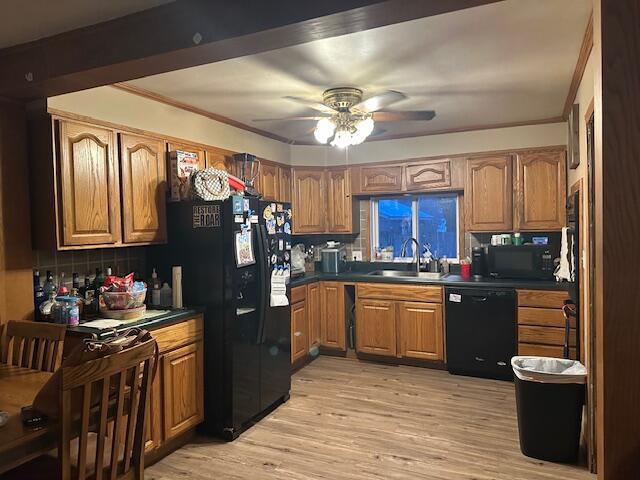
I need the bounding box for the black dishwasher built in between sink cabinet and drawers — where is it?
[445,287,516,380]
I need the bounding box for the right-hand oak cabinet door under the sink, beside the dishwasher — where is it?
[398,302,444,360]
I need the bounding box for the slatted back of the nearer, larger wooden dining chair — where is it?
[59,340,156,480]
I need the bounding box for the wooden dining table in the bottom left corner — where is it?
[0,363,56,474]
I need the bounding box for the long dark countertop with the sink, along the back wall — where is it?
[291,268,574,291]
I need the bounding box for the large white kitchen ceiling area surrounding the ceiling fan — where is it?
[129,0,591,141]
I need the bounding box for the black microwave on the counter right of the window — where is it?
[487,245,555,280]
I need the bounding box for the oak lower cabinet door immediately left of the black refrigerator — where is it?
[162,341,204,441]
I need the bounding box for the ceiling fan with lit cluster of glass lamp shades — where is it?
[254,87,436,148]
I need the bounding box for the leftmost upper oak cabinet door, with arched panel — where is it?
[57,120,121,246]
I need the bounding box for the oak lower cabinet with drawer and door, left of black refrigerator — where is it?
[145,315,204,458]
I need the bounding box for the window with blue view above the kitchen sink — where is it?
[371,193,458,258]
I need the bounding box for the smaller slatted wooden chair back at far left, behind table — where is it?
[0,320,67,372]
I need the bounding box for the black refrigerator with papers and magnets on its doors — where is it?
[166,196,292,440]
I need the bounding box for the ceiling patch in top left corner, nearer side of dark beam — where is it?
[0,0,173,48]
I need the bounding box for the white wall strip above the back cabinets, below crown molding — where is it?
[291,122,567,165]
